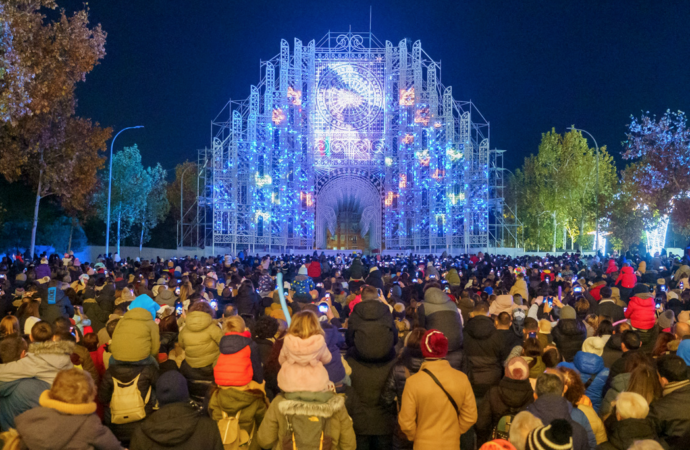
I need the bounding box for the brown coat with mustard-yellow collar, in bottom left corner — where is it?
[15,391,122,450]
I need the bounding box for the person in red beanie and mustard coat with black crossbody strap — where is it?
[398,329,477,450]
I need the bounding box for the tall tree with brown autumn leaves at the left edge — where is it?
[0,0,111,255]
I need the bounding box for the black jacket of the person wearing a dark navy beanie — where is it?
[129,403,223,450]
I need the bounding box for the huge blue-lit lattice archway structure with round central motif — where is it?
[206,33,494,251]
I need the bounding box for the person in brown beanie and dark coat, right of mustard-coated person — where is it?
[476,356,534,444]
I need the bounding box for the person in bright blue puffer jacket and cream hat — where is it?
[558,337,609,413]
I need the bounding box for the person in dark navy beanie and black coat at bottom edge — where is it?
[129,370,224,450]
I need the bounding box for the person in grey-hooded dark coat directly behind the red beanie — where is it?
[417,287,463,370]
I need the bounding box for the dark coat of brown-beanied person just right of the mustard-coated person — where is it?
[476,377,534,445]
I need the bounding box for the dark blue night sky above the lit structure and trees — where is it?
[58,0,690,173]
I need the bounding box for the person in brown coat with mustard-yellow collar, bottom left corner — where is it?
[14,368,122,450]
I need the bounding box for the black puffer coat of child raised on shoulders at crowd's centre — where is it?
[346,300,398,362]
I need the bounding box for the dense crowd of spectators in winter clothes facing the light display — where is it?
[0,252,690,450]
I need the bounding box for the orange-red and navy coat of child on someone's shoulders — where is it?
[213,331,264,386]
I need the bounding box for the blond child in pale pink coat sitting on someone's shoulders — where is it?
[278,311,333,392]
